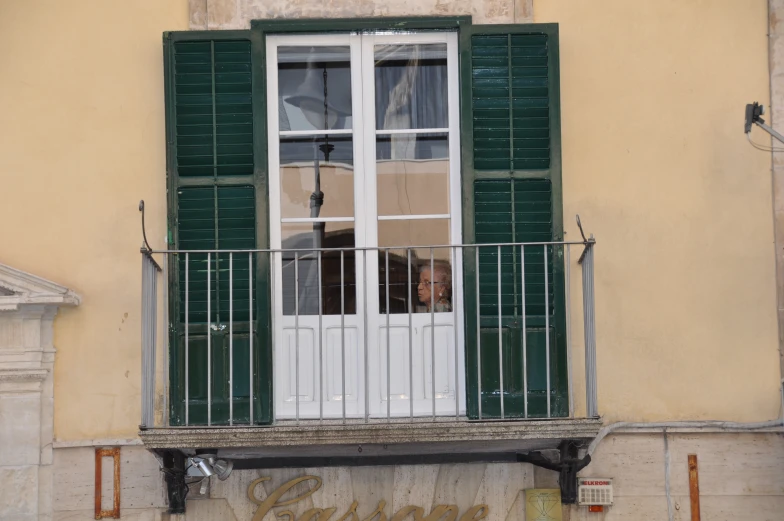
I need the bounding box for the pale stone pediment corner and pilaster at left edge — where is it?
[0,264,81,521]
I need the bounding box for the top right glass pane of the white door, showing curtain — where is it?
[375,43,449,130]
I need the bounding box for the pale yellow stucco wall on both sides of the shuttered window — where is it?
[0,0,779,439]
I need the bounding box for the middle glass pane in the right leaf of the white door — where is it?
[376,134,449,216]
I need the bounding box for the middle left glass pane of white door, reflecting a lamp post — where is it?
[280,136,354,218]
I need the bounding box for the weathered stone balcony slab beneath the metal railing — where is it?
[139,418,602,458]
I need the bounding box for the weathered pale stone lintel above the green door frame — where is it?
[188,0,533,30]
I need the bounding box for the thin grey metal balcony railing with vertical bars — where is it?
[141,239,598,429]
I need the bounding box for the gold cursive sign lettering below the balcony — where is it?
[248,476,490,521]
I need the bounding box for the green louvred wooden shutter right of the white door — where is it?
[461,24,568,418]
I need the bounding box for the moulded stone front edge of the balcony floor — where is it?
[139,418,602,451]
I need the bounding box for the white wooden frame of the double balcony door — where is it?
[266,31,467,419]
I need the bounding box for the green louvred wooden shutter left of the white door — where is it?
[164,31,271,425]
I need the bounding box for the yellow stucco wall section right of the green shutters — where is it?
[534,0,780,421]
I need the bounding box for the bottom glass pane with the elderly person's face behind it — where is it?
[378,219,453,313]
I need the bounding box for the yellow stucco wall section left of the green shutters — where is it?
[0,0,188,439]
